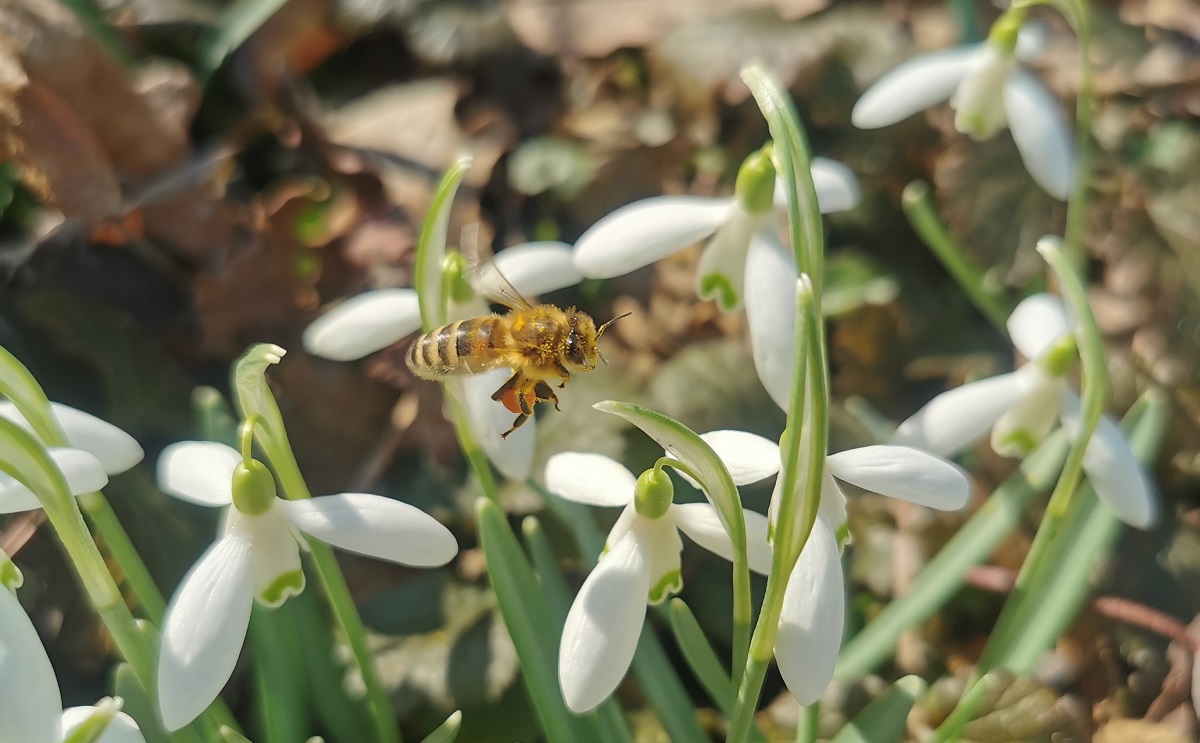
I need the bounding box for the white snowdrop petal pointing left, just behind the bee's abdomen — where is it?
[301,289,421,361]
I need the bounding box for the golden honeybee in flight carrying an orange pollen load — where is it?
[404,250,628,438]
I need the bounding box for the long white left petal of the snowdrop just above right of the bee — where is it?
[575,196,737,278]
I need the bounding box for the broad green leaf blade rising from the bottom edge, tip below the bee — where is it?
[475,498,594,743]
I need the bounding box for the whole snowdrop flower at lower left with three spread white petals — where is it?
[158,442,458,730]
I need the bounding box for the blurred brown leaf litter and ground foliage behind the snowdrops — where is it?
[0,0,1200,742]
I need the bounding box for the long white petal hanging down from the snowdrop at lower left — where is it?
[158,534,253,730]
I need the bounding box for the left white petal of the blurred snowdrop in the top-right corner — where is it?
[850,44,985,128]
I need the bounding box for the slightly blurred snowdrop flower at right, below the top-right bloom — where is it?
[893,294,1158,529]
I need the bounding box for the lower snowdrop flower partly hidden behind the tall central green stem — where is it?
[701,431,971,705]
